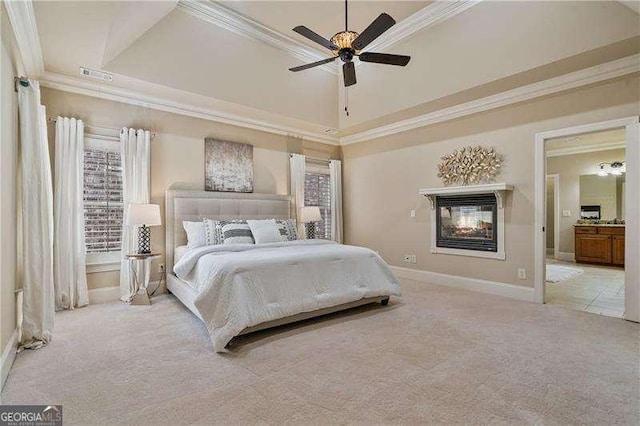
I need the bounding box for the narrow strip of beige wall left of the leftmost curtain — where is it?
[0,6,18,351]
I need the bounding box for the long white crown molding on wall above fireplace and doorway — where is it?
[340,55,640,145]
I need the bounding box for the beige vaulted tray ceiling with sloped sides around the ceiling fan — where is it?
[28,0,640,143]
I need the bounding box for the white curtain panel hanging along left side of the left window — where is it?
[53,117,89,310]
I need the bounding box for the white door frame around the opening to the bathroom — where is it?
[533,116,640,322]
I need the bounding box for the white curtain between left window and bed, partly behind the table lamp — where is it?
[120,128,151,302]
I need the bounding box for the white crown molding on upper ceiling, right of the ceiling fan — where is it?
[366,0,481,55]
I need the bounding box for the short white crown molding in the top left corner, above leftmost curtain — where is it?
[3,0,44,78]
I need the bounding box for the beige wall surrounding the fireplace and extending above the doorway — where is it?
[343,75,640,287]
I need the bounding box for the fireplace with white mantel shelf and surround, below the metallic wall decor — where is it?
[420,183,513,260]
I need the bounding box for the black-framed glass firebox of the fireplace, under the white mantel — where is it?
[436,194,498,252]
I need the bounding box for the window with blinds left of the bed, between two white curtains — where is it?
[84,138,123,263]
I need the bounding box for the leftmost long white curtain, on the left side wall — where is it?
[17,81,55,348]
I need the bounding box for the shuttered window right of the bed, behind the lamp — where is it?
[304,163,331,240]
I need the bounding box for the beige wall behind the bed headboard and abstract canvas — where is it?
[42,88,341,288]
